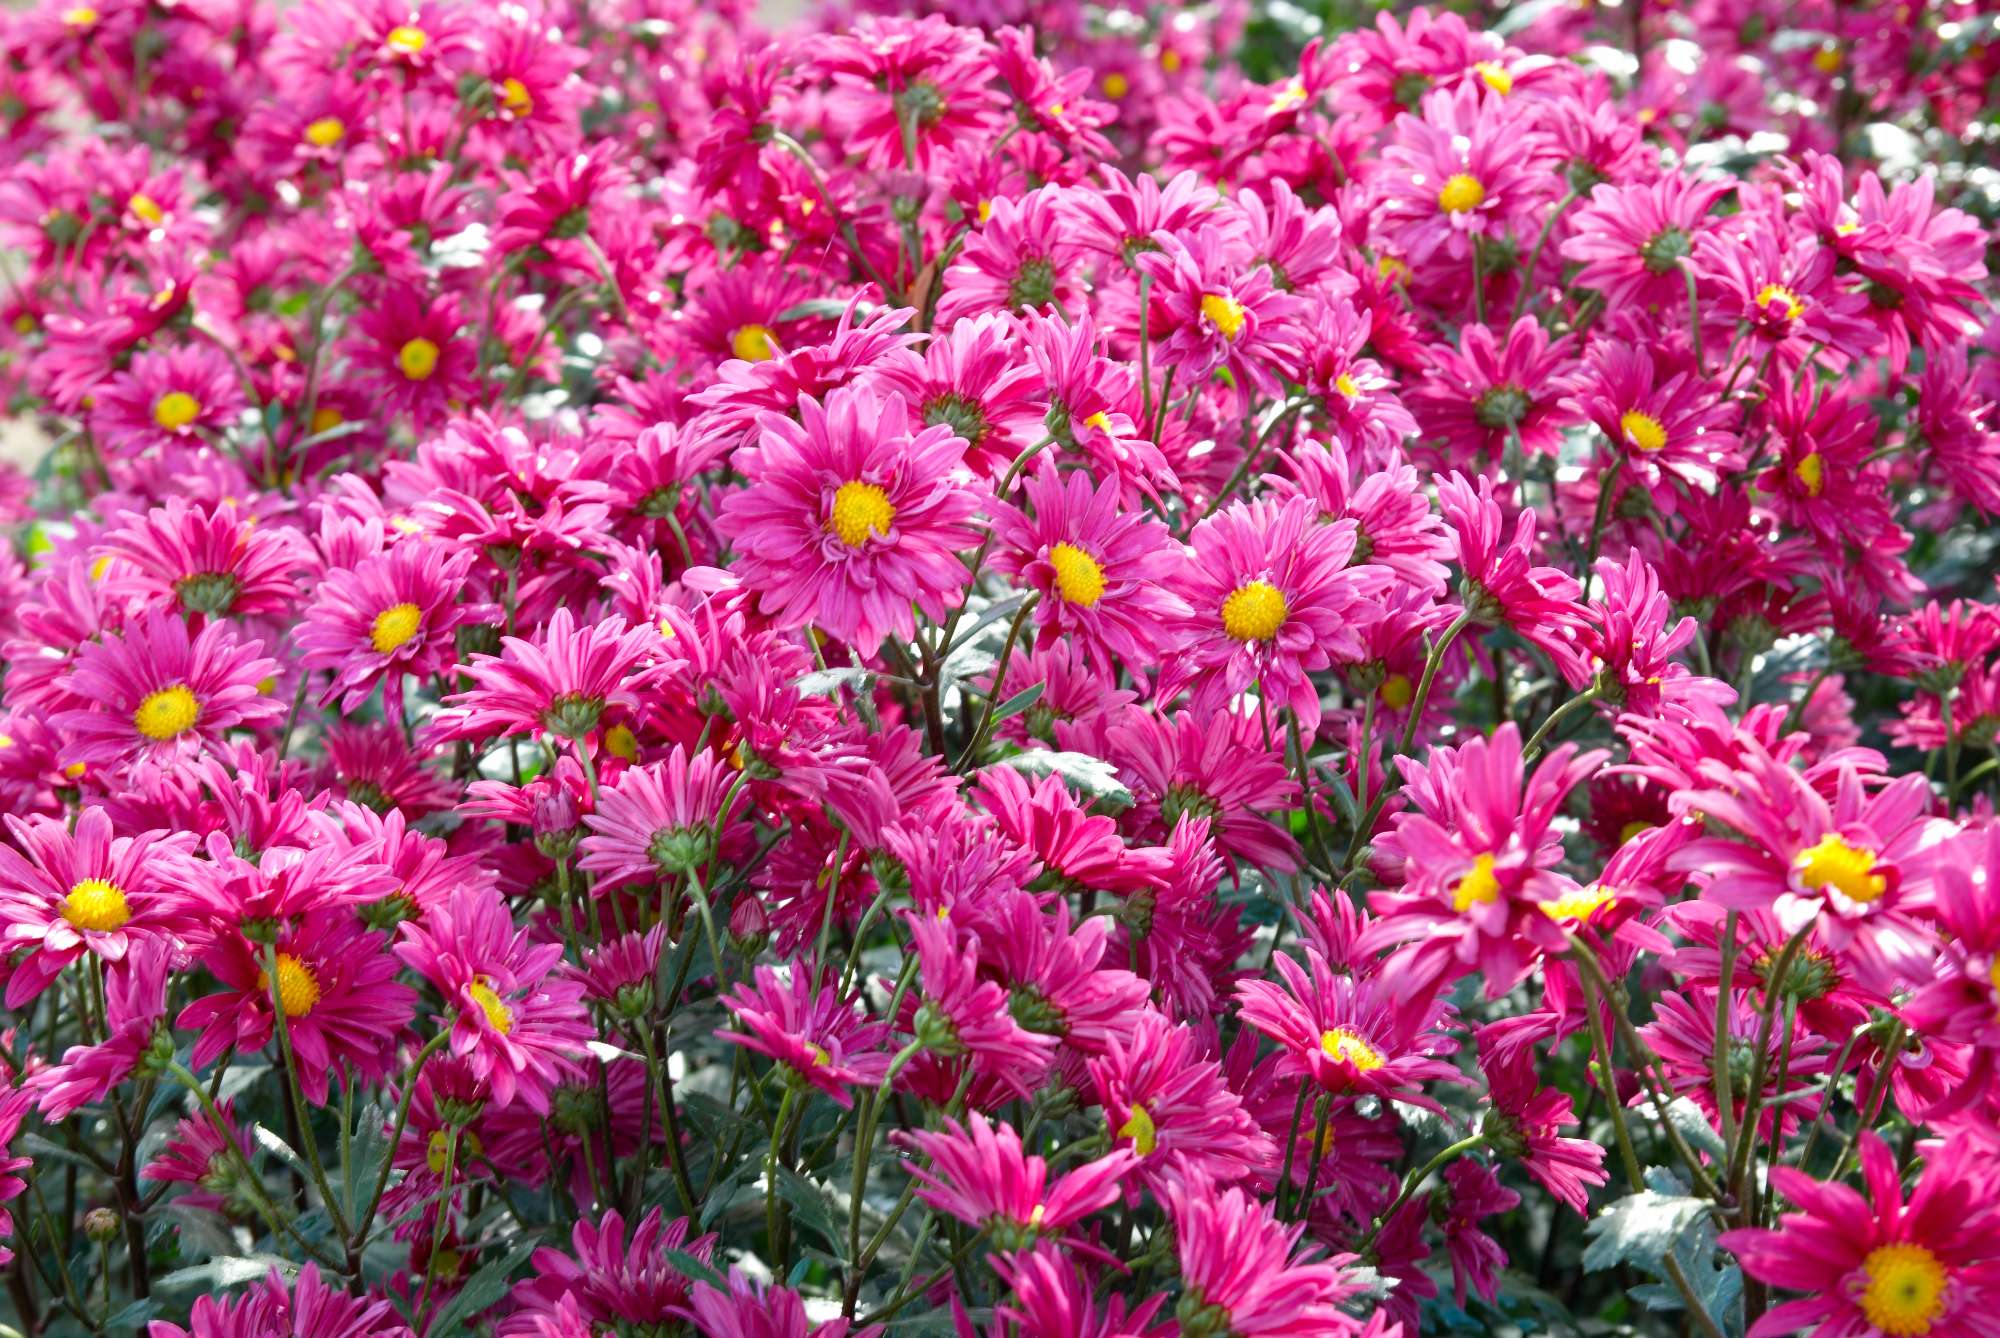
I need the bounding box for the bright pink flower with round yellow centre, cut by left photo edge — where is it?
[0,806,194,1008]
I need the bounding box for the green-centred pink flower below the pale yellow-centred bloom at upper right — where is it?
[1408,316,1576,460]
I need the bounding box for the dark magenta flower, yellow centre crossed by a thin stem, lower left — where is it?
[174,910,416,1106]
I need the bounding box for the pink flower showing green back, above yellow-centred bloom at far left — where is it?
[100,498,302,618]
